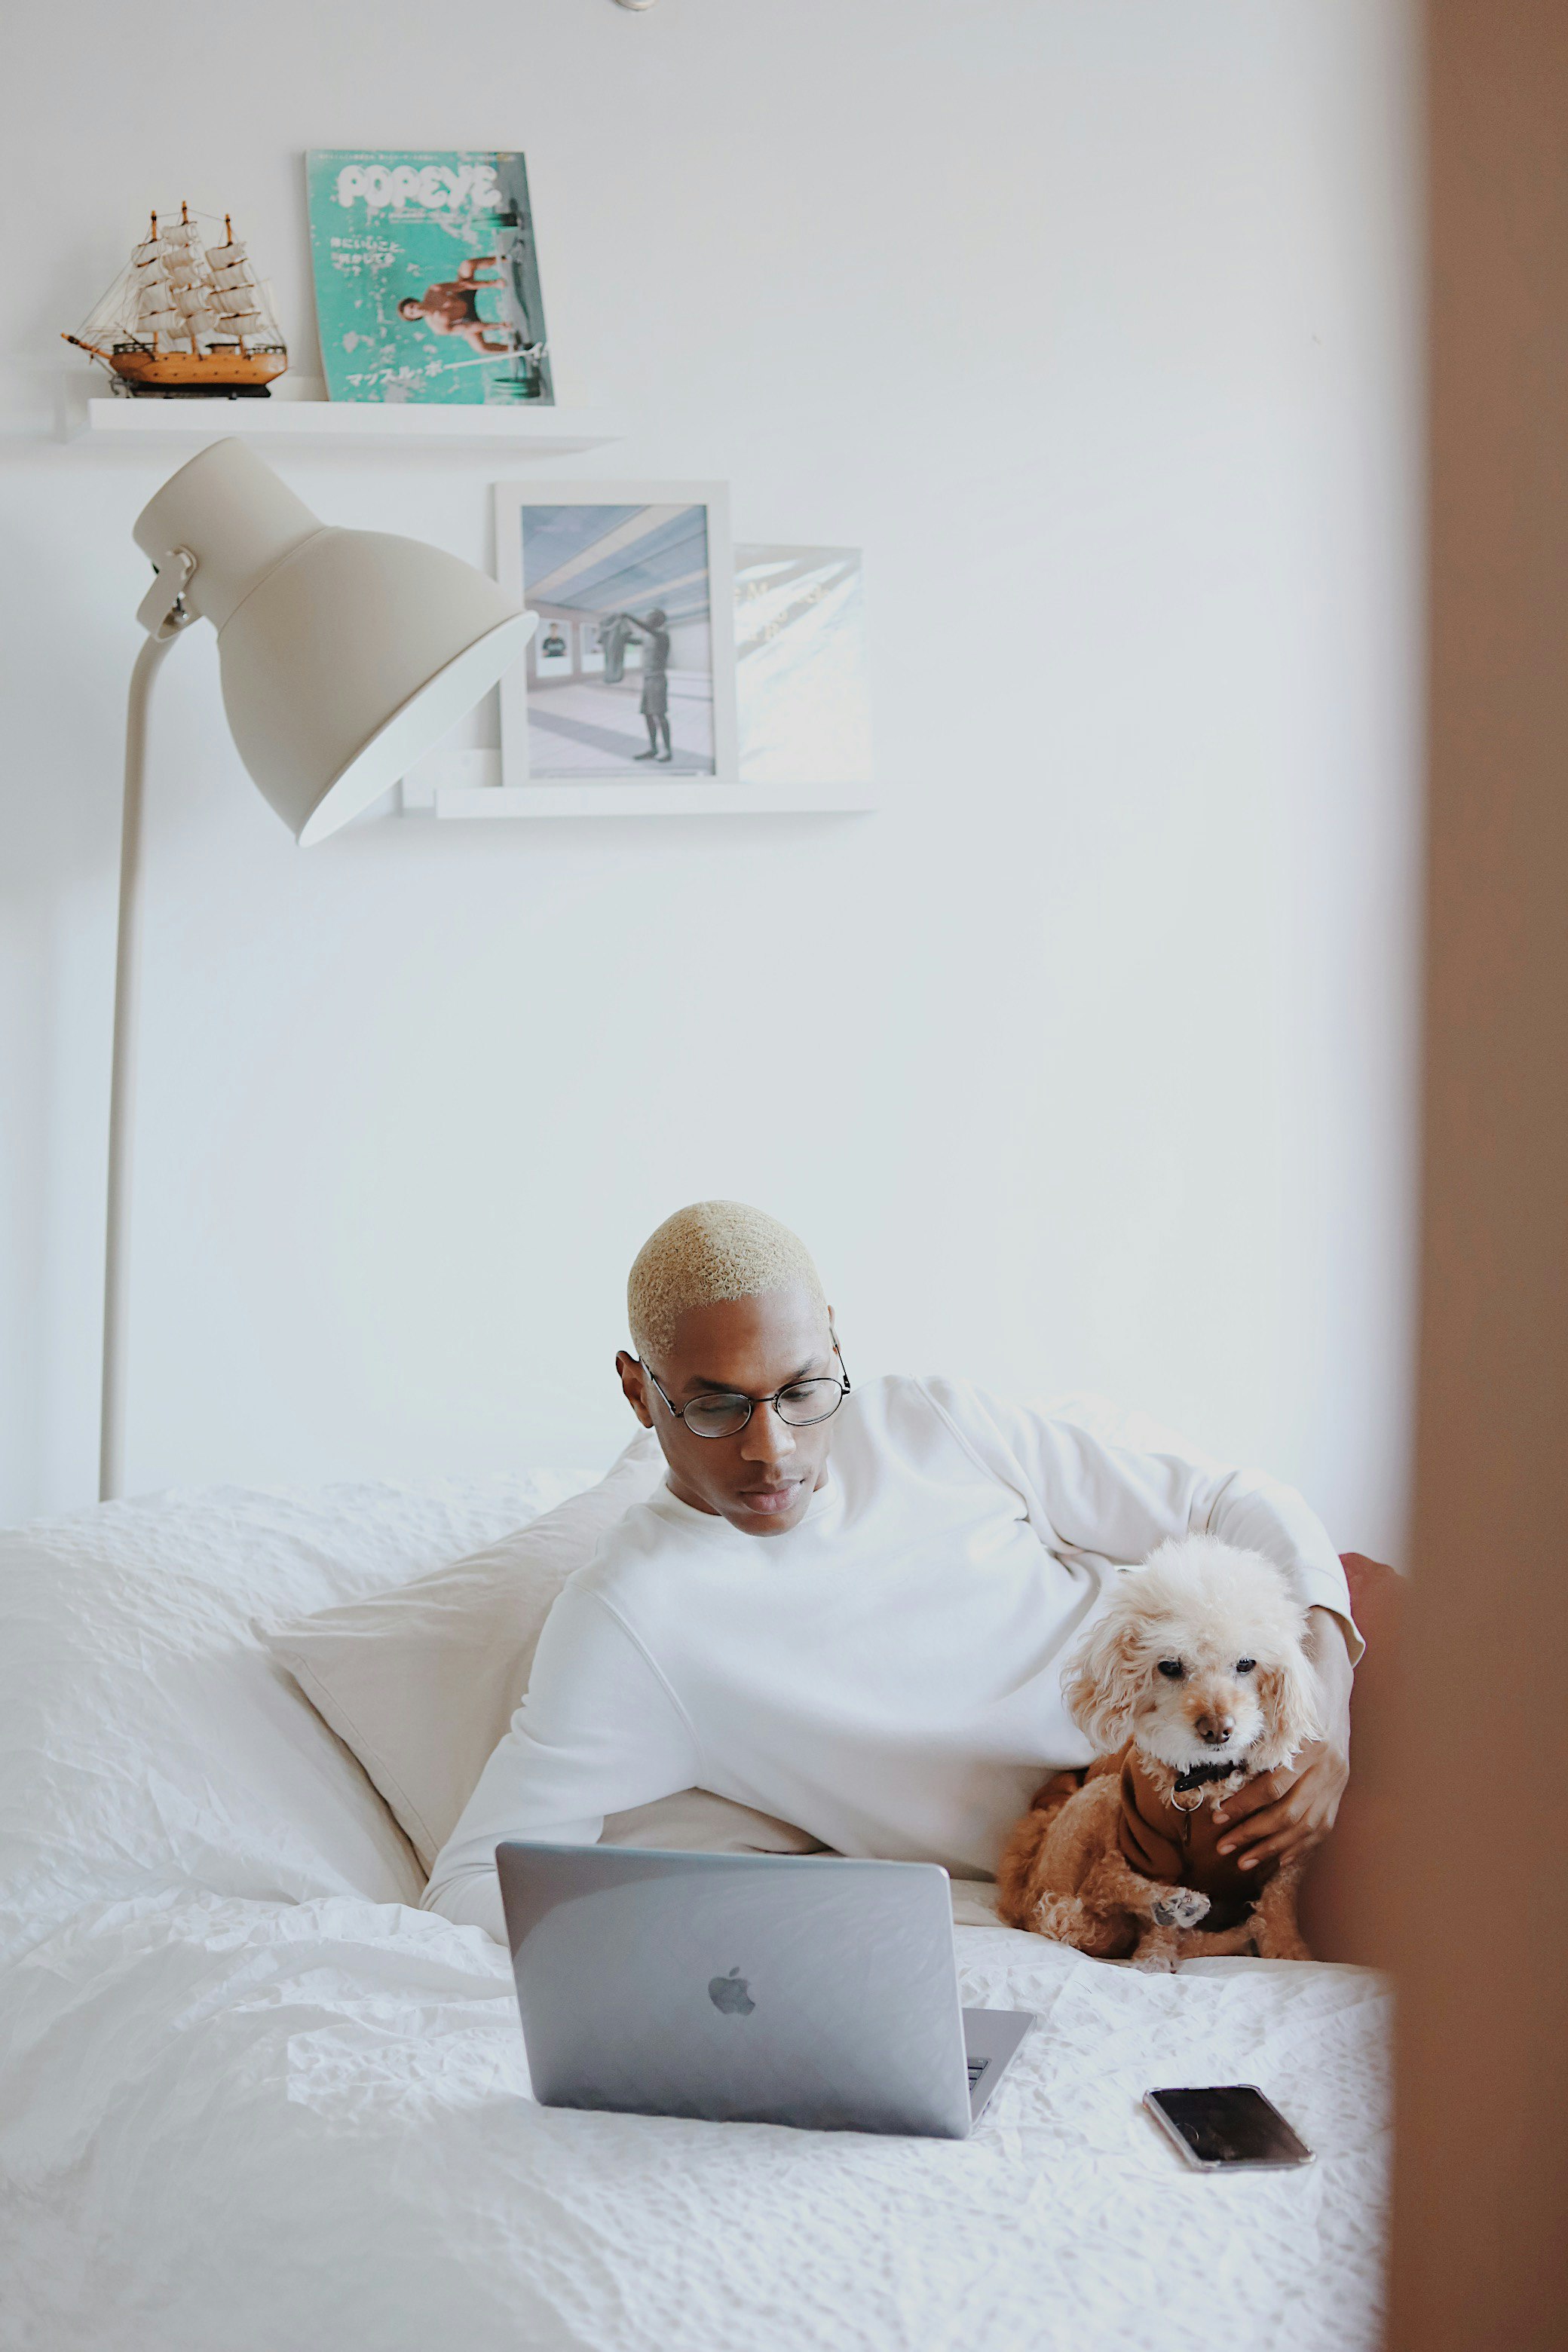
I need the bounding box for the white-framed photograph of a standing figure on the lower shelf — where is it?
[496,482,738,804]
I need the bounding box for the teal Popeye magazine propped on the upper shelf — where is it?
[305,149,555,407]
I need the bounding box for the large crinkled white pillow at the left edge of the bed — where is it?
[0,1472,587,1956]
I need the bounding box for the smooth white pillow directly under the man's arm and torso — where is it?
[261,1430,820,1875]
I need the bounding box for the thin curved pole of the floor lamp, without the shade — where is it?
[99,628,179,1503]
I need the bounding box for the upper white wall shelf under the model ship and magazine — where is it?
[63,400,623,458]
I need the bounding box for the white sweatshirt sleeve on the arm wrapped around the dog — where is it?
[924,1380,1366,1665]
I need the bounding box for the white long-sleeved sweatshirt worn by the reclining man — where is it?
[425,1378,1361,1940]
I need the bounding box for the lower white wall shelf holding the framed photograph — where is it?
[402,750,881,823]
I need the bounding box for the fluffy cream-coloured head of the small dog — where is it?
[1065,1536,1316,1771]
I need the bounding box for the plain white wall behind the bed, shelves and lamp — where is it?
[0,0,1415,1550]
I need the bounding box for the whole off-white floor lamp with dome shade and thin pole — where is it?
[99,439,536,1501]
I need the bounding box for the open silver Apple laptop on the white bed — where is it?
[496,1839,1034,2140]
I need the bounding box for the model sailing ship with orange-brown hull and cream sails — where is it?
[66,204,289,400]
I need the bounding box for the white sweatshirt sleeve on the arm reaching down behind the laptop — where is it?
[423,1581,700,1943]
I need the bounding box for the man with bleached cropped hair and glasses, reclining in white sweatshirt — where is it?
[425,1199,1361,1938]
